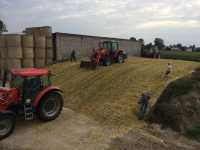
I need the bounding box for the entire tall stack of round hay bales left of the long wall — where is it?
[0,27,53,75]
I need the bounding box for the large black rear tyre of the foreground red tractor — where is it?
[38,91,64,121]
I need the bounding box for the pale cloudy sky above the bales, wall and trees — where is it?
[0,0,200,46]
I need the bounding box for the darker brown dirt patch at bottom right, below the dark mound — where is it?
[107,125,200,150]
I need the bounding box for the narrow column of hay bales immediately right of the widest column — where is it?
[22,34,34,68]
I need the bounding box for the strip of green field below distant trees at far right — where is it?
[161,51,200,61]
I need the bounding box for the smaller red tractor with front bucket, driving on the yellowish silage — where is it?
[80,41,127,69]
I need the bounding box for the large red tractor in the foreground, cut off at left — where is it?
[0,68,63,140]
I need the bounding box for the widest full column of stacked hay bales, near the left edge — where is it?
[5,34,22,69]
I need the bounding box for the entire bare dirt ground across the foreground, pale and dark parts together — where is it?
[0,108,200,150]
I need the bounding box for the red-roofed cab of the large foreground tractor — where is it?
[10,68,51,103]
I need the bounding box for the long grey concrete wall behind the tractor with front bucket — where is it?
[53,33,141,61]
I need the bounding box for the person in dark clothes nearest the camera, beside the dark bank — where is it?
[138,92,151,117]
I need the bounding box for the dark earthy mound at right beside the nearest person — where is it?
[149,69,200,132]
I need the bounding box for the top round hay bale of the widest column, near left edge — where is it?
[5,34,21,47]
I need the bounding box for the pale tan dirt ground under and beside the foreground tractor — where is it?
[0,108,109,150]
